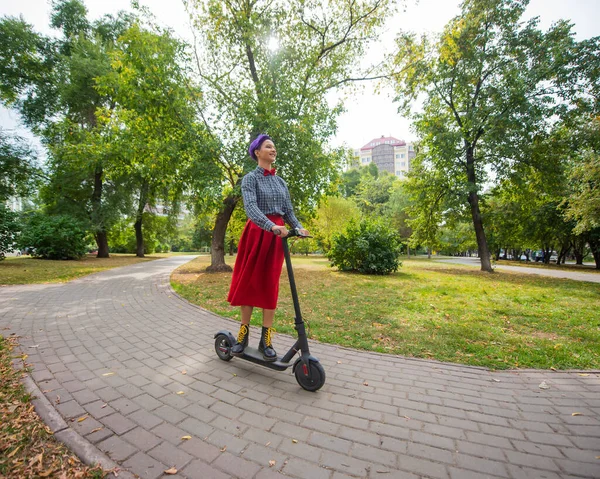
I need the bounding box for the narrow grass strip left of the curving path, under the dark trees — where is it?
[0,254,168,285]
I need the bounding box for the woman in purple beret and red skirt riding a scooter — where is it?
[227,135,309,361]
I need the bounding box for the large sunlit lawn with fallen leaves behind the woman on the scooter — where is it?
[172,256,600,369]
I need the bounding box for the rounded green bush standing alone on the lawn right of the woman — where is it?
[327,221,401,274]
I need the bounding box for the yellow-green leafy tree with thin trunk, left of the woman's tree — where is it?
[96,24,218,257]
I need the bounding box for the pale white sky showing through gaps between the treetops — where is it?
[0,0,600,154]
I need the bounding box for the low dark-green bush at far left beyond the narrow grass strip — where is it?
[18,213,88,259]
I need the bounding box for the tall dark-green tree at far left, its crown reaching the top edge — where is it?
[0,0,132,257]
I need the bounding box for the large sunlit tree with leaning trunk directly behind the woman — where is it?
[185,0,394,271]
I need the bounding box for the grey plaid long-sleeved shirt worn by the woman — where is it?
[242,166,302,231]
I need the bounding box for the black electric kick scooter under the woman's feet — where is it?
[215,229,325,391]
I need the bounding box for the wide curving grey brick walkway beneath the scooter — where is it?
[0,256,600,479]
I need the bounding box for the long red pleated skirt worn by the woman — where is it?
[227,215,284,309]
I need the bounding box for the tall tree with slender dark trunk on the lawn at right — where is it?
[393,0,575,272]
